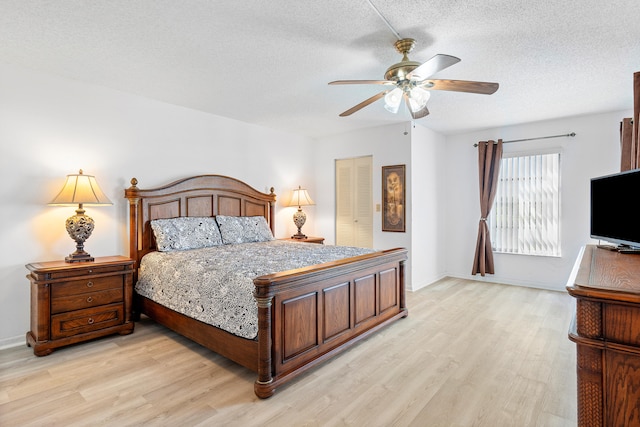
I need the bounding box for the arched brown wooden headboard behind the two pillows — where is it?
[124,175,276,272]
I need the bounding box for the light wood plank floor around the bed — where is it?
[0,279,576,427]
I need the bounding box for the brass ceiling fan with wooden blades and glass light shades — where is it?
[329,38,499,119]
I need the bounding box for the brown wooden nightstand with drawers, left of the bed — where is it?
[26,256,134,356]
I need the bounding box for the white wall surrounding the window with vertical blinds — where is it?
[445,110,632,290]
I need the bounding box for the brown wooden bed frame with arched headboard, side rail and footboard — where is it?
[125,175,408,398]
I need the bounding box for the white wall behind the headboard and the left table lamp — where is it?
[0,63,318,347]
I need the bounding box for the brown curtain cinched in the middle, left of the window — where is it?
[471,139,502,276]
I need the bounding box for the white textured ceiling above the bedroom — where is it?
[0,0,640,137]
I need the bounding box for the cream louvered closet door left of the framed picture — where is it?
[336,156,373,248]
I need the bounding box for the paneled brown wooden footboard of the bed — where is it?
[254,249,408,398]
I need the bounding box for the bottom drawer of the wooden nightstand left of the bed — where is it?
[51,304,124,339]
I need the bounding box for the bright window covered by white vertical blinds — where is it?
[489,153,560,256]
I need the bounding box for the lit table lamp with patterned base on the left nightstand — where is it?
[49,169,113,262]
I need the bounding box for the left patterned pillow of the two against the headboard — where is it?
[151,217,222,252]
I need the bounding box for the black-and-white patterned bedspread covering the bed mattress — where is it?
[135,240,374,339]
